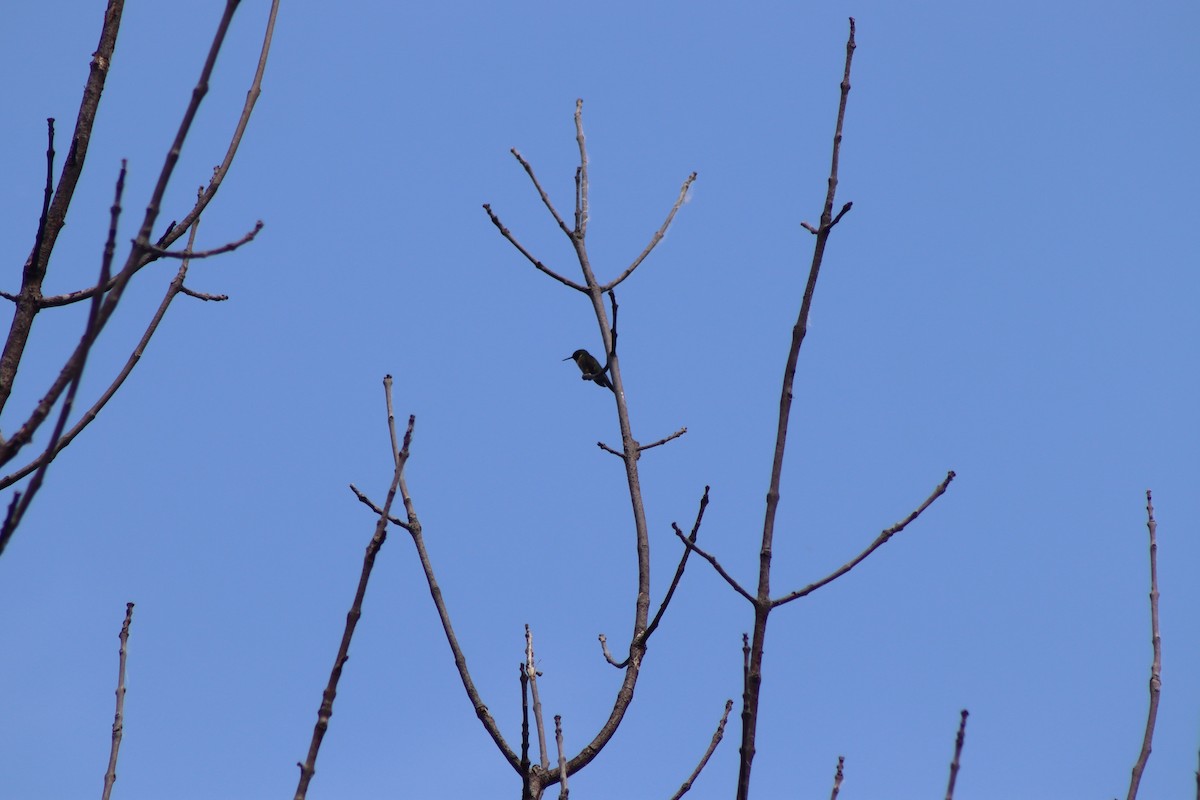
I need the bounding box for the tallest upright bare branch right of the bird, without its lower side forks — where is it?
[737,17,856,800]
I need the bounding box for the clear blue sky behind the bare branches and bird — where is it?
[0,0,1200,800]
